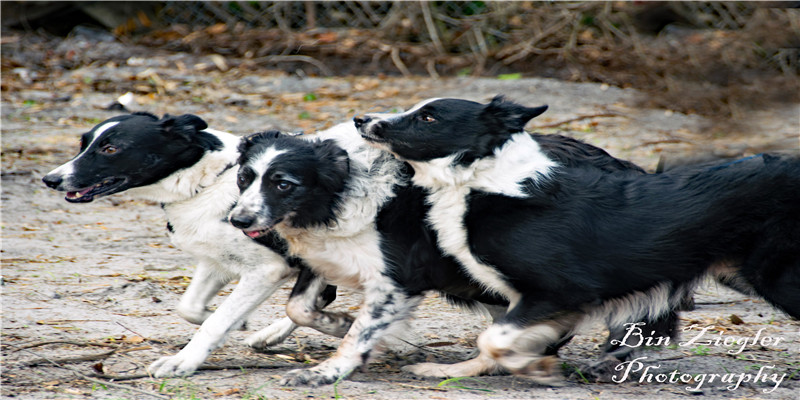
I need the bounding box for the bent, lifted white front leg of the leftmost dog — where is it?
[177,261,232,325]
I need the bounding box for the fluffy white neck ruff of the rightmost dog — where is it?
[408,132,558,197]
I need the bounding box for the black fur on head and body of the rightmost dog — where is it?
[357,95,800,373]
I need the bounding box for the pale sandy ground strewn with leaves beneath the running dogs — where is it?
[1,36,800,399]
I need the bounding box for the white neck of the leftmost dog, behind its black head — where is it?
[128,129,239,205]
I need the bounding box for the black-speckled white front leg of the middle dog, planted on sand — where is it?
[281,279,422,386]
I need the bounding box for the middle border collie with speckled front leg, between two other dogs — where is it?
[230,117,677,385]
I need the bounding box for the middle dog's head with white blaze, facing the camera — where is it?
[229,131,350,238]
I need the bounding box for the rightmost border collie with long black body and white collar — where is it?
[356,96,800,384]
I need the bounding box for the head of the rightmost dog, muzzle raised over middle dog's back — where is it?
[354,96,547,164]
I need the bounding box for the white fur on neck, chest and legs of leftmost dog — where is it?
[46,126,304,377]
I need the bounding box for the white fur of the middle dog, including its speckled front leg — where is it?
[234,124,428,386]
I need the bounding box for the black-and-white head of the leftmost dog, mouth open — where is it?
[42,113,222,203]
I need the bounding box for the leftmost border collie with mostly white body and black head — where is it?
[43,113,349,377]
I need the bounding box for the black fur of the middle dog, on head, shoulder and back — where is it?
[232,125,677,372]
